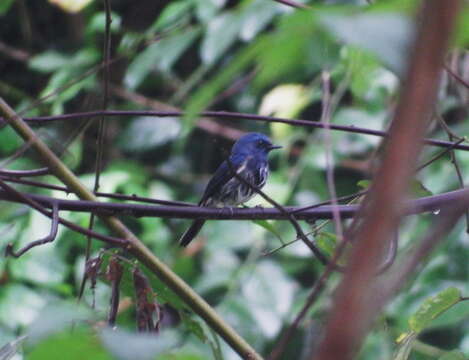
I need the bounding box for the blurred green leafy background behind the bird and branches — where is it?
[0,0,469,360]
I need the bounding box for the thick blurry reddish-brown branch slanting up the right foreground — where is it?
[314,0,460,360]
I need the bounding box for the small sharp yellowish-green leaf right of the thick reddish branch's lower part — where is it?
[409,287,461,333]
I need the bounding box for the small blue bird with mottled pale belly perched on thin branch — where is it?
[179,133,281,246]
